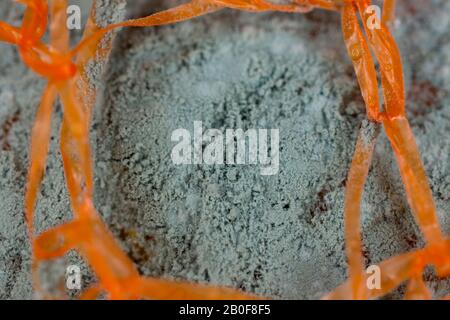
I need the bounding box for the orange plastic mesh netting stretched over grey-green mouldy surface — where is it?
[0,0,450,299]
